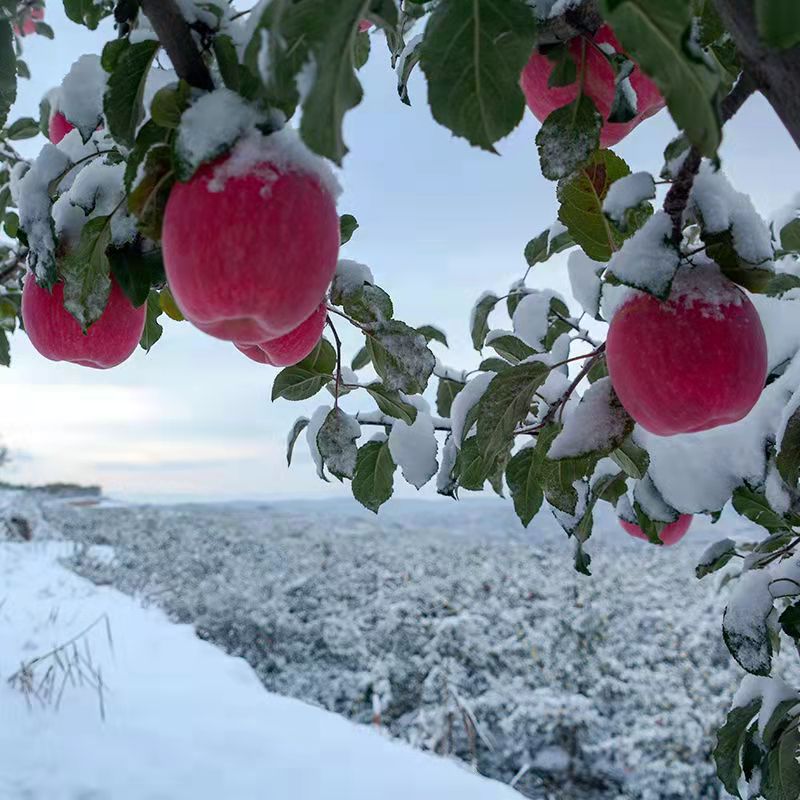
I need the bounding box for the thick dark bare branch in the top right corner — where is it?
[714,0,800,147]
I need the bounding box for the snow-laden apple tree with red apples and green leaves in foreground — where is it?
[0,0,800,800]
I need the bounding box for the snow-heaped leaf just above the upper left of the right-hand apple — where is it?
[608,211,680,298]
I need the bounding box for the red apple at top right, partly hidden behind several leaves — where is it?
[522,25,664,147]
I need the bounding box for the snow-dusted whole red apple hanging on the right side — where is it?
[606,265,767,436]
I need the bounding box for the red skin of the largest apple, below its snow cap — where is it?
[162,157,339,345]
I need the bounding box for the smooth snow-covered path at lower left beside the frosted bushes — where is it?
[0,543,520,800]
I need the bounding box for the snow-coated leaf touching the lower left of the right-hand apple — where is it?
[548,378,634,459]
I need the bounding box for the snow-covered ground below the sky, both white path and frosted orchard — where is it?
[0,494,798,800]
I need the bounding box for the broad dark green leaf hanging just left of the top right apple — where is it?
[421,0,537,152]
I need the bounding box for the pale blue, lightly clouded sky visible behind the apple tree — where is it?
[0,3,800,499]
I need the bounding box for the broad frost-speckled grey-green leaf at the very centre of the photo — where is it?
[366,320,436,394]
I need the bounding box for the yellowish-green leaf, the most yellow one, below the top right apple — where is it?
[557,150,632,261]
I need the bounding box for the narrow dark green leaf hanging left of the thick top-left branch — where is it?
[103,39,159,147]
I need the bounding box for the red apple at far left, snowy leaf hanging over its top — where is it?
[22,275,147,369]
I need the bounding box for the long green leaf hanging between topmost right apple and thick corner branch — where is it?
[600,0,722,158]
